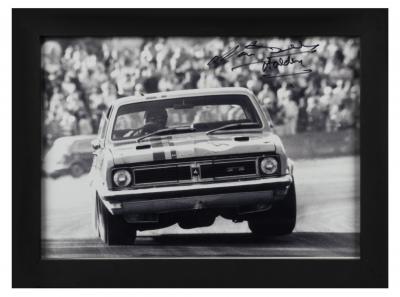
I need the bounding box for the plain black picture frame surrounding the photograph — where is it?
[12,9,388,288]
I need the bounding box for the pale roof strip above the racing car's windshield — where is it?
[113,87,253,107]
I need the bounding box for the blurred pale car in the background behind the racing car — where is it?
[43,135,96,177]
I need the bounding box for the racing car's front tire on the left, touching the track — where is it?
[96,195,136,245]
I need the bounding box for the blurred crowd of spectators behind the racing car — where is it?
[42,37,360,142]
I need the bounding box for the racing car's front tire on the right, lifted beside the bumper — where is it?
[248,182,296,237]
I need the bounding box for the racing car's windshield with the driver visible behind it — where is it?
[111,95,262,140]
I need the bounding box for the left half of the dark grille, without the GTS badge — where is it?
[133,165,192,185]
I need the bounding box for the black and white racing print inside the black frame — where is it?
[41,34,363,259]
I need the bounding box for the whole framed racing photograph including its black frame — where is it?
[12,9,388,287]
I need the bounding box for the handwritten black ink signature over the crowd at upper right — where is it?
[207,40,319,78]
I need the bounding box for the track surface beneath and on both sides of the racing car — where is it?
[42,156,360,259]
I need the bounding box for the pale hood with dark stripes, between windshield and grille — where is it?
[111,132,276,165]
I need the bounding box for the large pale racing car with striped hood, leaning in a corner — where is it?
[91,88,296,245]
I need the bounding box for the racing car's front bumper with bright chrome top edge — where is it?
[99,175,293,214]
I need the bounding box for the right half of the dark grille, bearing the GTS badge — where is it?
[200,159,257,179]
